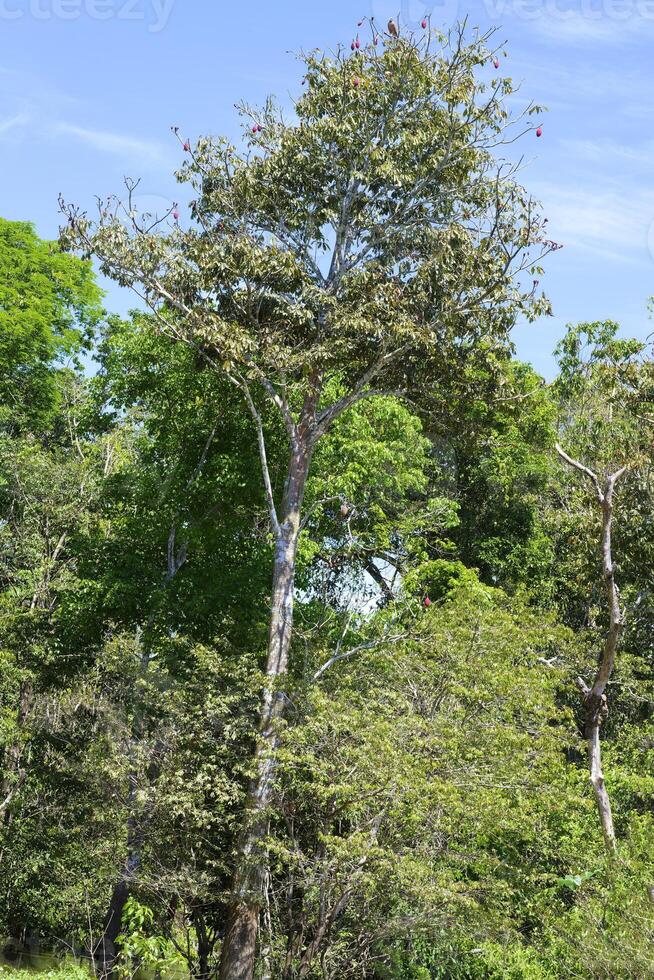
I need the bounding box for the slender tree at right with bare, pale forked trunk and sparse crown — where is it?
[553,321,654,855]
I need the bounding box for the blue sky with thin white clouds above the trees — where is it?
[0,0,654,374]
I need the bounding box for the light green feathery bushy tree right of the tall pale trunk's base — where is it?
[271,585,598,977]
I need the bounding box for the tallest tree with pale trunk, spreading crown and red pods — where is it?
[62,21,552,980]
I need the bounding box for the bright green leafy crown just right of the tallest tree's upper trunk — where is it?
[301,398,457,599]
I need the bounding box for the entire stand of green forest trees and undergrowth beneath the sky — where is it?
[0,21,654,980]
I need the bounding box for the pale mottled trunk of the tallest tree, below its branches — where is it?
[220,436,312,980]
